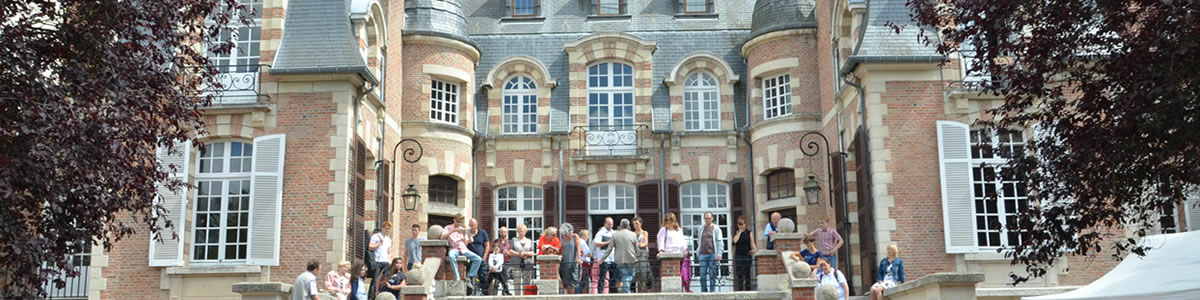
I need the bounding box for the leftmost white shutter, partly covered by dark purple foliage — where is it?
[150,142,192,266]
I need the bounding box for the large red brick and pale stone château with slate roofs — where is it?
[70,0,1200,299]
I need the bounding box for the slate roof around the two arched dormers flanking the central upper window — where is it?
[472,29,750,133]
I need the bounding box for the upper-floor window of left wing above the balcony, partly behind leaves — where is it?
[209,0,263,73]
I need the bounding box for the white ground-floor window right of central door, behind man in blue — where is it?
[679,182,732,284]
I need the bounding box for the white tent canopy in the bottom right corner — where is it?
[1024,232,1200,300]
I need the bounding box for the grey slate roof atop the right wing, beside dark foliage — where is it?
[841,0,943,73]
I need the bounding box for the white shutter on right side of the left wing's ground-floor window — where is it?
[246,134,284,265]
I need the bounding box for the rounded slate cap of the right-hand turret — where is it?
[745,0,817,41]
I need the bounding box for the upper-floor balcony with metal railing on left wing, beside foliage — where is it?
[205,65,270,107]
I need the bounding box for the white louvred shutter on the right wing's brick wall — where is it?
[937,121,979,253]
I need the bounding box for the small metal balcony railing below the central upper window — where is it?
[570,124,650,157]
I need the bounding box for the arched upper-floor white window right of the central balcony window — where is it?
[683,73,721,131]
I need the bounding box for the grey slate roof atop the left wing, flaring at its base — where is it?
[270,0,378,83]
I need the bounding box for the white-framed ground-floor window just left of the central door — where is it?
[496,186,545,240]
